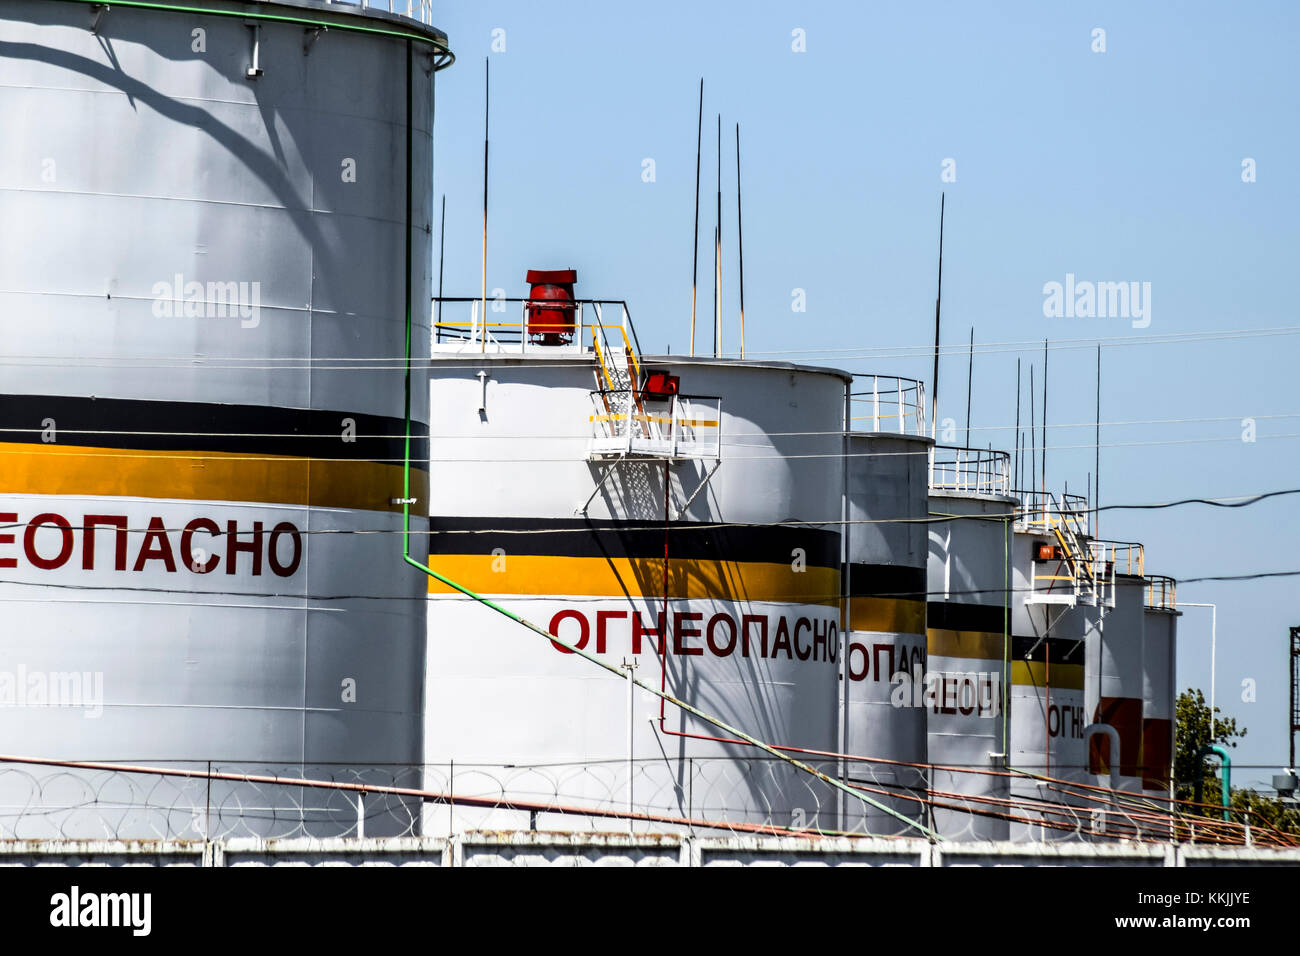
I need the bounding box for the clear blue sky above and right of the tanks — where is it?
[434,0,1300,783]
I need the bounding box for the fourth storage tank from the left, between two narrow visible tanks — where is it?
[926,468,1015,840]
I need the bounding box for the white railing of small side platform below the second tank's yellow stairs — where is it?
[589,389,722,459]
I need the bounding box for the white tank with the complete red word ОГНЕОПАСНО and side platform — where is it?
[425,351,848,832]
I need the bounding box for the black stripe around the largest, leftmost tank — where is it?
[0,394,429,464]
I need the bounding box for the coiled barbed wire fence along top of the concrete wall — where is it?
[0,756,1284,847]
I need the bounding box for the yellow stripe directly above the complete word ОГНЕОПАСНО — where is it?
[429,554,840,606]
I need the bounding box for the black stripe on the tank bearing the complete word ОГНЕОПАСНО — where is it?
[429,515,840,568]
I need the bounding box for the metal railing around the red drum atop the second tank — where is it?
[433,295,641,360]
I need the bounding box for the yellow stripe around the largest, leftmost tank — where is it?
[0,442,429,515]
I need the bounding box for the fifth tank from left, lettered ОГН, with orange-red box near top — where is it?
[1010,502,1093,842]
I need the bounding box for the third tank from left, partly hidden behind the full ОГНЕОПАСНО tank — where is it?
[840,433,932,834]
